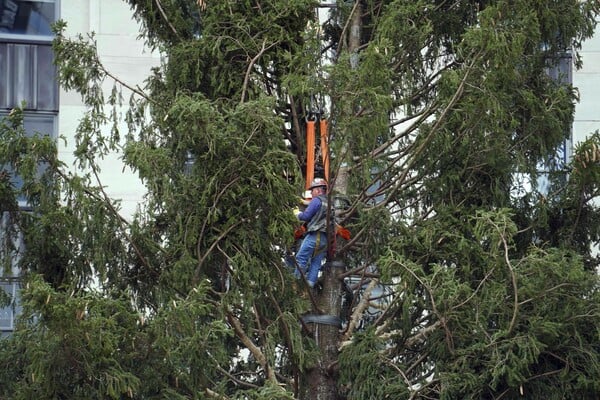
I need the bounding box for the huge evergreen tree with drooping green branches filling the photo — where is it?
[0,0,600,400]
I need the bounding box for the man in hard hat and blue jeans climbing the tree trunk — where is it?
[294,178,327,288]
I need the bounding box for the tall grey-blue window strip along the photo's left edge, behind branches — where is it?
[0,0,60,336]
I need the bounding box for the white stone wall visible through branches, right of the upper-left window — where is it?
[58,0,160,218]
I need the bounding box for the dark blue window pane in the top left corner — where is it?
[0,0,56,36]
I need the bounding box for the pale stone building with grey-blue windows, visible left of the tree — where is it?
[0,0,160,335]
